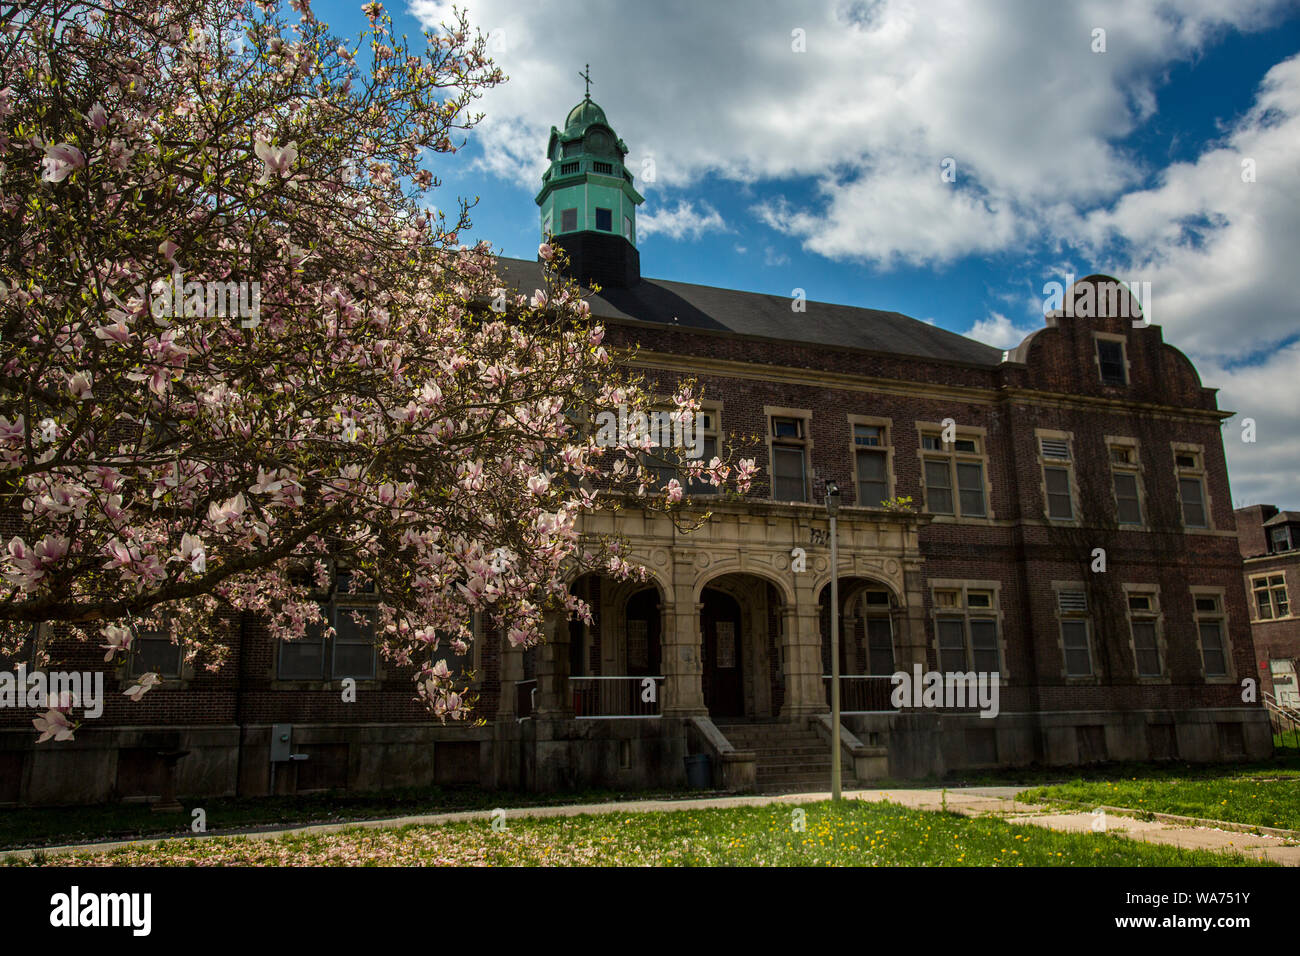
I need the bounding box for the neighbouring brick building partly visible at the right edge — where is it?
[1234,505,1300,710]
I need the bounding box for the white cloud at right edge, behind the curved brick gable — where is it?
[1055,56,1300,507]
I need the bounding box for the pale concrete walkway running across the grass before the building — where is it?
[10,787,1300,866]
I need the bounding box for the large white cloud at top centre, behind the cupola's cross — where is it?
[411,0,1284,263]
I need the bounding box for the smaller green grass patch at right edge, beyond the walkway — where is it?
[1017,770,1300,830]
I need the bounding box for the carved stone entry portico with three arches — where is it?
[503,501,926,721]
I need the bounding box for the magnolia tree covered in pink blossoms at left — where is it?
[0,0,754,737]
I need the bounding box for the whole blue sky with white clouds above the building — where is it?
[313,0,1300,509]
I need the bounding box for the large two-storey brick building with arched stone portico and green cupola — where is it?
[0,99,1271,803]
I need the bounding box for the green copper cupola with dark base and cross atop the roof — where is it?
[537,74,645,286]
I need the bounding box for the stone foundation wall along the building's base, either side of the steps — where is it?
[0,708,1273,805]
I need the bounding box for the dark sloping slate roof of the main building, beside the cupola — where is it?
[497,258,1002,365]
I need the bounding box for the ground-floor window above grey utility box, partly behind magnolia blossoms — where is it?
[278,572,376,680]
